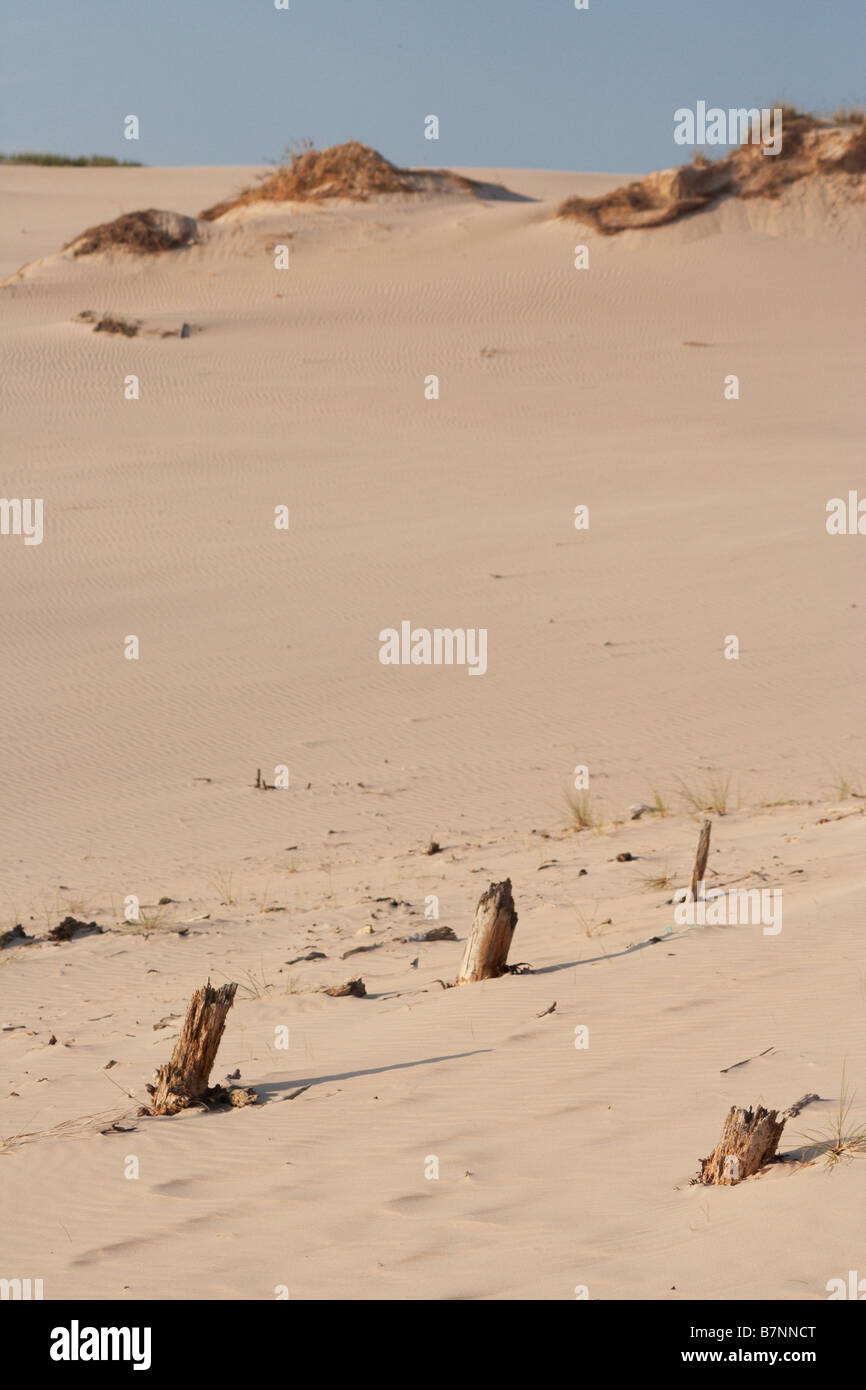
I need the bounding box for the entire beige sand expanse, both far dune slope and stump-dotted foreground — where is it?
[0,167,866,1298]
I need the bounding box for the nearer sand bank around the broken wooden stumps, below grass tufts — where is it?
[0,806,866,1300]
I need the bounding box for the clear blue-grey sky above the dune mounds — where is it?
[0,0,866,172]
